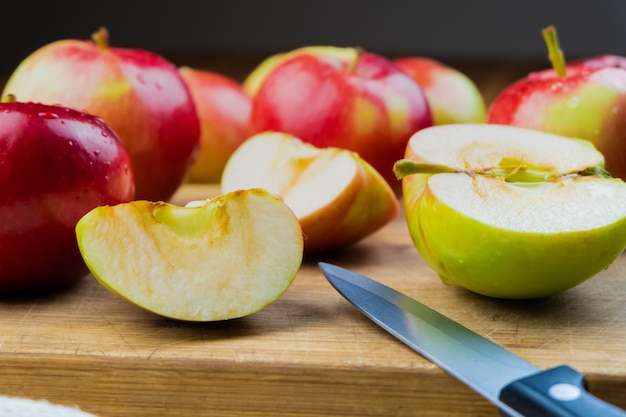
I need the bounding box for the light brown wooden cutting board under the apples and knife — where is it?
[0,185,626,417]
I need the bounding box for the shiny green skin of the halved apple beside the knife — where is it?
[407,174,626,299]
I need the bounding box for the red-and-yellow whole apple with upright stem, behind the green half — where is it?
[487,27,626,179]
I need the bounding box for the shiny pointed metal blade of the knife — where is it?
[319,262,540,416]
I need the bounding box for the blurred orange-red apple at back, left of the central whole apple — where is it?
[179,67,252,183]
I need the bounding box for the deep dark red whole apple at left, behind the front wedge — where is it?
[0,102,135,294]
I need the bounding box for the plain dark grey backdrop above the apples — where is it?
[0,0,626,73]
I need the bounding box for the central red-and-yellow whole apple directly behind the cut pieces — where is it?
[244,46,433,190]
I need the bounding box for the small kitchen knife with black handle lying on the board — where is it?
[319,262,626,417]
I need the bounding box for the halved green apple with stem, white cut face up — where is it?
[394,124,626,299]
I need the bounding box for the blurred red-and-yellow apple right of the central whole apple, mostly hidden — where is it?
[393,56,487,125]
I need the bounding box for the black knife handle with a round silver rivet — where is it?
[500,366,626,417]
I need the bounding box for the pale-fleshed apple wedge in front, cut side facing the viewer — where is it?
[76,189,303,321]
